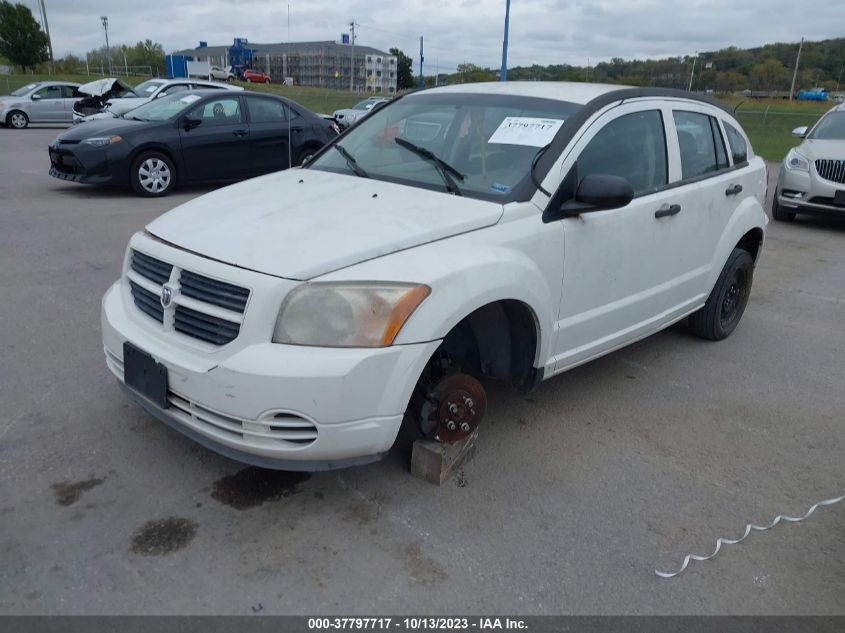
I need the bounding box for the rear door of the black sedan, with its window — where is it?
[244,95,296,175]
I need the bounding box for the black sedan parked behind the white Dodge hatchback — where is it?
[50,90,338,196]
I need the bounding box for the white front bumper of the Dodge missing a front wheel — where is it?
[102,282,439,471]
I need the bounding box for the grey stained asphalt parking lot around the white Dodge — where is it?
[0,127,845,615]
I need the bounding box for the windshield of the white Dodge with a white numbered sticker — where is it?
[308,93,581,203]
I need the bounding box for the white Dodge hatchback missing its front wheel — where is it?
[102,82,766,470]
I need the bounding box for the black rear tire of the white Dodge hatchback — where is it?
[689,248,754,341]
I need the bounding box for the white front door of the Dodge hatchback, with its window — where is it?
[555,101,684,372]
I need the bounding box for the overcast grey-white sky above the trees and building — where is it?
[26,0,845,74]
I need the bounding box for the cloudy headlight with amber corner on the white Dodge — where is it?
[273,282,431,347]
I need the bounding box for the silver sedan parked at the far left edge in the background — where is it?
[0,81,82,130]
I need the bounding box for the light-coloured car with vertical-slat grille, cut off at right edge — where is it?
[772,104,845,222]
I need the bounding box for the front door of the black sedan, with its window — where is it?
[179,95,250,180]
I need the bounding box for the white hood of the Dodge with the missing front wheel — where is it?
[147,169,503,280]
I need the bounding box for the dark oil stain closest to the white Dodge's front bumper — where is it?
[211,466,311,510]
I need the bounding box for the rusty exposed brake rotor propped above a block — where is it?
[423,374,487,444]
